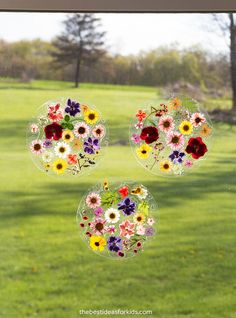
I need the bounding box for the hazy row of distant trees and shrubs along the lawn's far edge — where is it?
[0,40,231,89]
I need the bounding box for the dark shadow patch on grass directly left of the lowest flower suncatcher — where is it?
[0,183,92,227]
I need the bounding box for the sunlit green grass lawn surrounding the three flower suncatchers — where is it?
[0,81,236,318]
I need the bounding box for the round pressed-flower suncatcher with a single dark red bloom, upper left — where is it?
[28,98,107,175]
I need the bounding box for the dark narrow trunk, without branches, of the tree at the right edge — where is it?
[229,13,236,111]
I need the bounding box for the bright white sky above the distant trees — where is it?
[0,12,228,55]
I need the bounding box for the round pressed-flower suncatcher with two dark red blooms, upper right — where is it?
[130,97,212,175]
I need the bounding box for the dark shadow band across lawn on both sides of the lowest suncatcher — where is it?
[1,160,236,226]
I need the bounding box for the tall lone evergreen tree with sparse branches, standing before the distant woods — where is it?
[54,13,105,87]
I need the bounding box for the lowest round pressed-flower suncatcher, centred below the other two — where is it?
[77,182,156,258]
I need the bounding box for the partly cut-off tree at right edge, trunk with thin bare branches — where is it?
[213,13,236,111]
